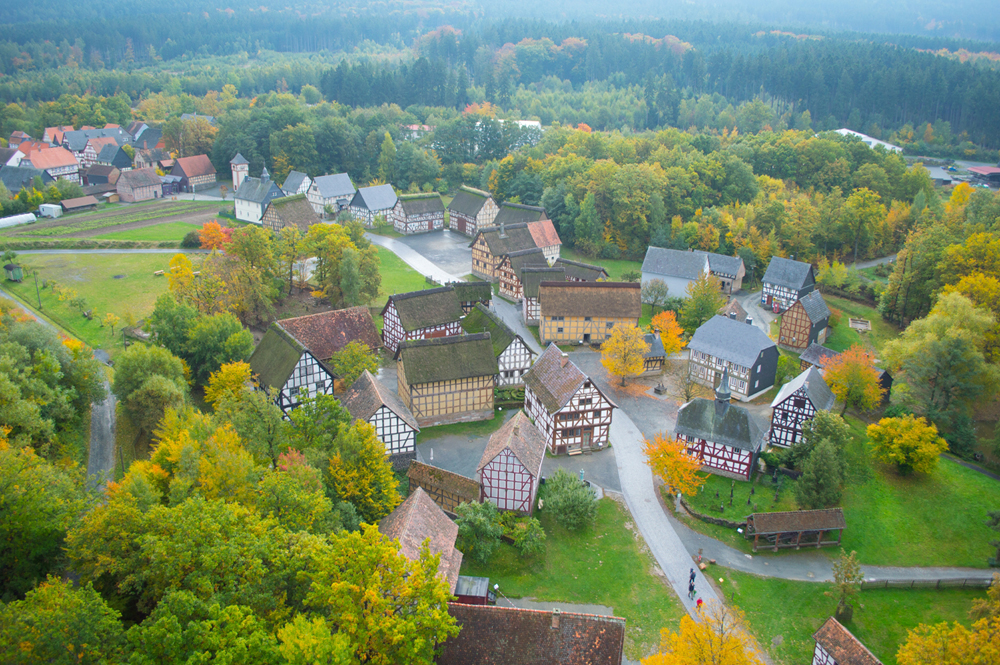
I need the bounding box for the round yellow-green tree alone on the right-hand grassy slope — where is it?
[868,415,948,475]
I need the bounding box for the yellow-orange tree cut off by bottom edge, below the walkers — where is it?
[642,602,763,665]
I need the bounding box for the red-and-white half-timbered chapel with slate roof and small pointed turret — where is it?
[676,370,766,480]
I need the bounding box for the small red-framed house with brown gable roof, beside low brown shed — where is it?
[476,411,546,515]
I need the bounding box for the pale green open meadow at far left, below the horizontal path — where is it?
[5,254,186,355]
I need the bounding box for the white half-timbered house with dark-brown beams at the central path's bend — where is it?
[524,344,618,455]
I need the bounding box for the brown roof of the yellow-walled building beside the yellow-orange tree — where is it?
[538,282,642,320]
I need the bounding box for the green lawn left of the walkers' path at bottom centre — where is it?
[462,499,684,660]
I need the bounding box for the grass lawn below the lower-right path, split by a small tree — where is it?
[714,568,986,665]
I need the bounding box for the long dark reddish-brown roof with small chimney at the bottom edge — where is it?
[435,603,625,665]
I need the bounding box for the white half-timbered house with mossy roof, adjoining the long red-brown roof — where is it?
[250,324,333,414]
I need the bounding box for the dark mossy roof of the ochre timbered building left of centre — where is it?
[396,333,497,385]
